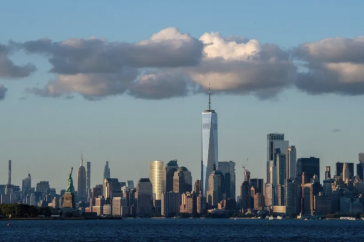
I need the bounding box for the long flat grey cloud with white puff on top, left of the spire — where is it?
[17,28,203,74]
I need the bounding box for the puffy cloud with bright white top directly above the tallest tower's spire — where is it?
[190,33,296,99]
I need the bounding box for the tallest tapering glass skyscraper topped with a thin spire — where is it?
[201,88,219,197]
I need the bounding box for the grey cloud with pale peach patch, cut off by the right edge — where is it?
[293,37,364,95]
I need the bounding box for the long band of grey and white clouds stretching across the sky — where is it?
[0,28,364,100]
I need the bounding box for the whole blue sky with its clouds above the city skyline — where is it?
[0,0,364,192]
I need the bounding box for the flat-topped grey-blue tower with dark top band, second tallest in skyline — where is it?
[267,133,288,182]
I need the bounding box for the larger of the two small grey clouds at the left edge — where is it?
[0,44,36,79]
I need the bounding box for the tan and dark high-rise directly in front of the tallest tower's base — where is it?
[206,165,224,207]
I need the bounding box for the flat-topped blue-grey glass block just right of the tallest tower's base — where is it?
[219,161,236,199]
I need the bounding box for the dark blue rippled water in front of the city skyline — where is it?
[0,219,364,242]
